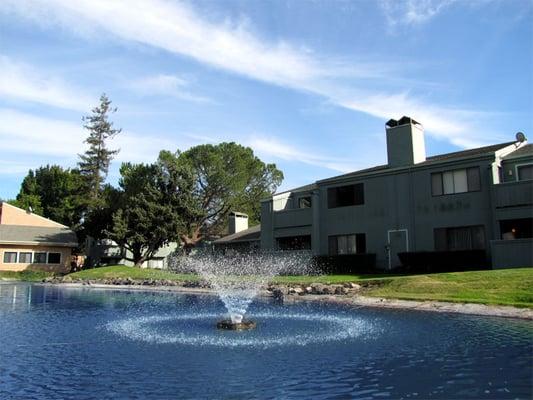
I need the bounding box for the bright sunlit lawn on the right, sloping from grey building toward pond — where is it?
[365,268,533,308]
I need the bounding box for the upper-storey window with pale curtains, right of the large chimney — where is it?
[431,167,481,196]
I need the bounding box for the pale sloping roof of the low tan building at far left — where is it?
[0,225,78,247]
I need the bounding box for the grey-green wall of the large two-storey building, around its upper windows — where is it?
[319,159,492,268]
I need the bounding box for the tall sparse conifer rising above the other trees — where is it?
[78,94,121,207]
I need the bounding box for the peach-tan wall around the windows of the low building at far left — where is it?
[0,245,72,272]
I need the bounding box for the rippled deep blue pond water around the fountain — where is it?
[0,283,533,399]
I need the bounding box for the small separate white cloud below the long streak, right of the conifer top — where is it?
[128,74,211,103]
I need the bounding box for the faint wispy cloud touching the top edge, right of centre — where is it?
[379,0,456,27]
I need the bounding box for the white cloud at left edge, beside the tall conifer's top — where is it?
[0,55,92,112]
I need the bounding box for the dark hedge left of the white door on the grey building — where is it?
[313,253,382,274]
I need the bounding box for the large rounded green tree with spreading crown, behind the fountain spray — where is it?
[159,143,283,248]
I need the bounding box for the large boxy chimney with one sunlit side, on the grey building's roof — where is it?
[385,117,426,167]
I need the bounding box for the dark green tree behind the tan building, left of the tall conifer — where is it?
[12,165,85,228]
